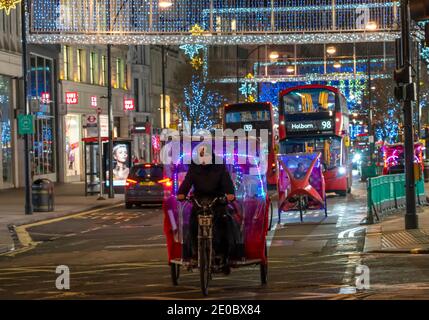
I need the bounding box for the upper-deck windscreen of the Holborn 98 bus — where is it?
[282,89,335,114]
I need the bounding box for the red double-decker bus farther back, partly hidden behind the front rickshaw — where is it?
[223,102,277,186]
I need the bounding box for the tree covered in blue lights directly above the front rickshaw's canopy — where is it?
[177,75,224,133]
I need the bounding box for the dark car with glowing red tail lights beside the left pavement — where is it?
[125,163,172,209]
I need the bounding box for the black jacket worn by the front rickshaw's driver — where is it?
[178,164,235,198]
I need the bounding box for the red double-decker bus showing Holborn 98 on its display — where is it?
[279,85,352,196]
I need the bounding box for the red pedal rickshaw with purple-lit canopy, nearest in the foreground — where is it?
[163,139,270,296]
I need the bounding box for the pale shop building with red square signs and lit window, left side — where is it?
[57,45,133,182]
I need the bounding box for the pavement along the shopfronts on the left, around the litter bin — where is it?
[0,183,124,253]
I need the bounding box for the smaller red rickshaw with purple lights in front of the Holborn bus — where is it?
[277,152,328,223]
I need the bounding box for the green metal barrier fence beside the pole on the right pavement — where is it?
[367,173,427,223]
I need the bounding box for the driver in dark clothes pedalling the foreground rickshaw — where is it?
[177,147,235,273]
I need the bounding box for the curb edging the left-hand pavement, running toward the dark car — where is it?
[0,199,123,255]
